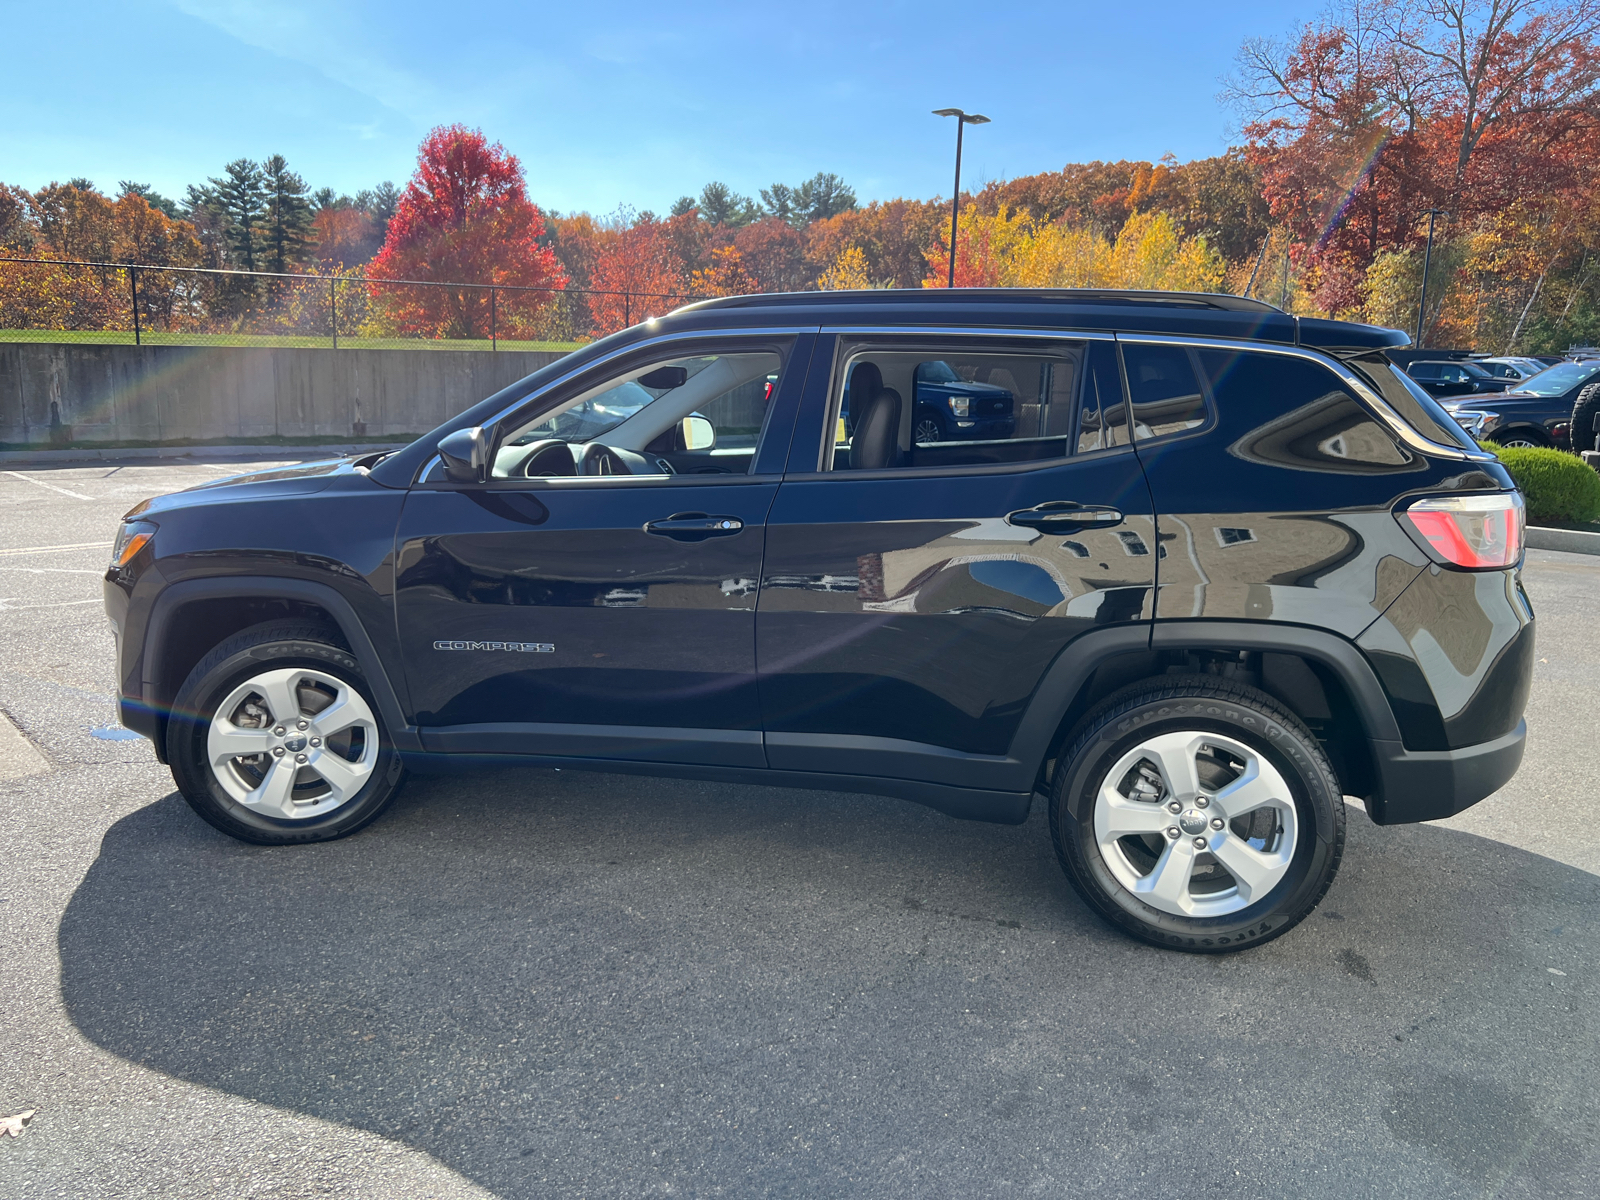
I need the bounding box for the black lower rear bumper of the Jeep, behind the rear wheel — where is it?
[1368,722,1528,826]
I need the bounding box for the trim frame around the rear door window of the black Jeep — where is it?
[806,325,1133,480]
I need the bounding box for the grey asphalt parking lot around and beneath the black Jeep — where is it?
[0,464,1600,1200]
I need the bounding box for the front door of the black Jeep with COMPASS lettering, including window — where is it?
[395,338,810,766]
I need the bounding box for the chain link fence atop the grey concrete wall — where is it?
[0,258,701,350]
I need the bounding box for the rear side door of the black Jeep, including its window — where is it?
[757,333,1157,790]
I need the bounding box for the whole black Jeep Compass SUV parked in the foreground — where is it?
[106,290,1533,952]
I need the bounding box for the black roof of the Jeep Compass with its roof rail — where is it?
[661,288,1411,354]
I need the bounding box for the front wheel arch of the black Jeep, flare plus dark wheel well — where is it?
[138,576,421,755]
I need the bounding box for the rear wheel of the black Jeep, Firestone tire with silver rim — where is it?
[1050,675,1344,954]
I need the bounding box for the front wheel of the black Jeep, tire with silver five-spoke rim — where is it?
[166,621,405,846]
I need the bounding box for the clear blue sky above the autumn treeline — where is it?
[0,0,1318,214]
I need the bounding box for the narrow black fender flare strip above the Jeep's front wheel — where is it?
[141,574,422,750]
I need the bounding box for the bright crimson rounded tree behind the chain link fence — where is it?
[368,125,566,338]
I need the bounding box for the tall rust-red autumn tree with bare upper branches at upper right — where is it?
[1229,0,1600,324]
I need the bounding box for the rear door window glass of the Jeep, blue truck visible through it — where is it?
[824,342,1100,470]
